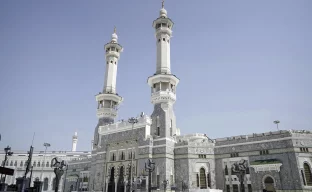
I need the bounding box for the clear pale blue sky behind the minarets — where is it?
[0,0,312,151]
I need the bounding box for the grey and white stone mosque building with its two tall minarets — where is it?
[61,3,312,192]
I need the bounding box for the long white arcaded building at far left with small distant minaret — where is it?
[0,132,91,192]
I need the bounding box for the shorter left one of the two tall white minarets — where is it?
[93,27,123,146]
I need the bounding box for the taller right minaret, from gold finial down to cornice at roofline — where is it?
[148,2,179,137]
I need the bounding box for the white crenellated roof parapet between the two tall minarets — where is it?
[99,115,152,135]
